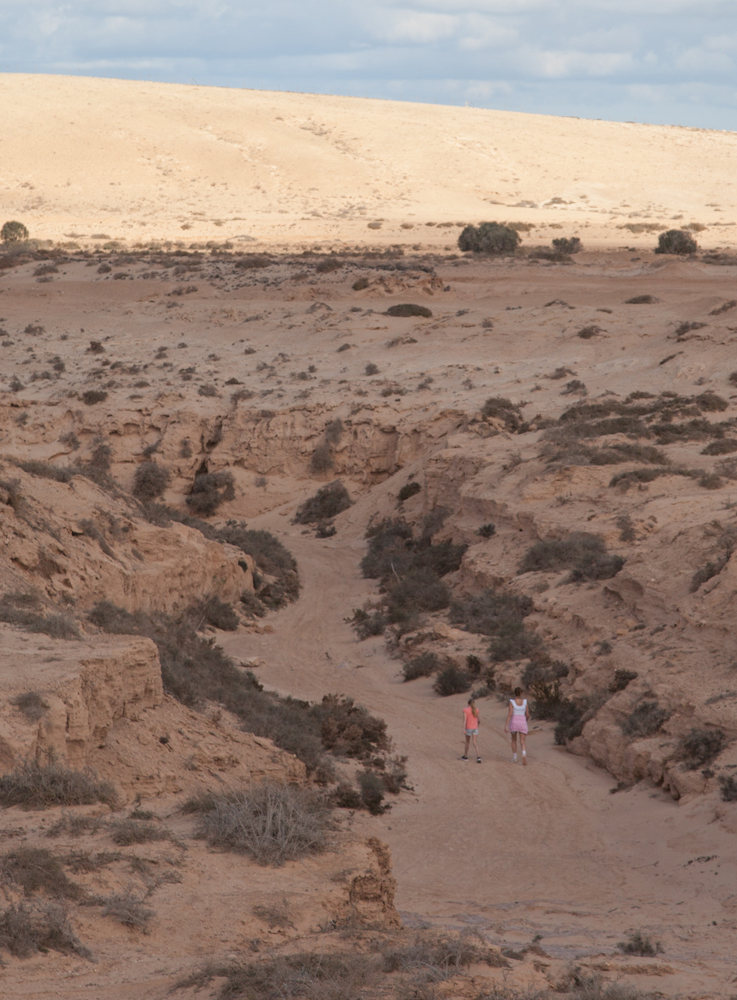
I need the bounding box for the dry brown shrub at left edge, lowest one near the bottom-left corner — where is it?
[0,900,91,958]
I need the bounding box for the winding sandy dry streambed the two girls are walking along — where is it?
[225,511,737,986]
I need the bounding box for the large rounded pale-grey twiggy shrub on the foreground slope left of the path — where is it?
[198,783,328,865]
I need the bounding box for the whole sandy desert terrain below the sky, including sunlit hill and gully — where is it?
[0,75,737,1000]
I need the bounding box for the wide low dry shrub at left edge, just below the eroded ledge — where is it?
[0,761,117,809]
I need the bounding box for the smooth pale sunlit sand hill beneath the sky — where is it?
[0,74,737,248]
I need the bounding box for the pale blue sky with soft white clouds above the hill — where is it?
[0,0,737,131]
